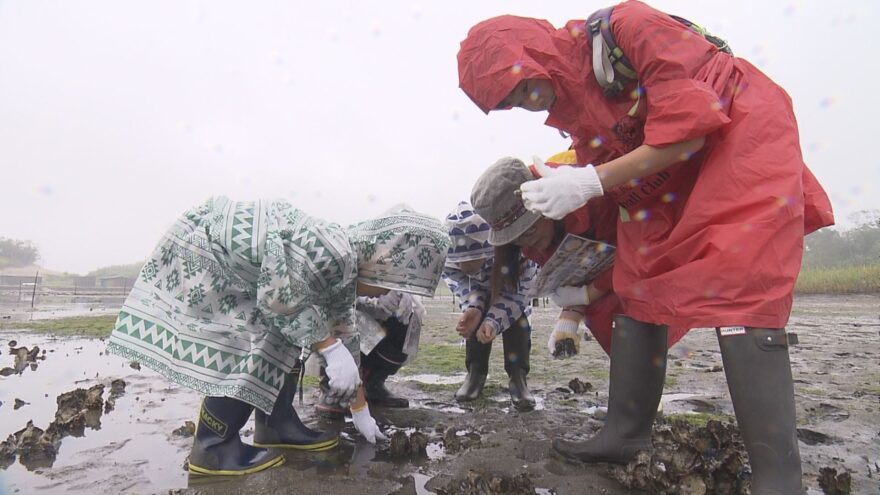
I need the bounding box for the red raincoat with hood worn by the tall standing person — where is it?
[459,1,833,334]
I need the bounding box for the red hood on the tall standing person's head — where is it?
[458,15,585,118]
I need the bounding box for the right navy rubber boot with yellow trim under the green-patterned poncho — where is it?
[254,367,339,451]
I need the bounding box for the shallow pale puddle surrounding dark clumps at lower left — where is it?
[0,332,200,493]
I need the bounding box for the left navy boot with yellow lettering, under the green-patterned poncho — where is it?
[189,397,284,476]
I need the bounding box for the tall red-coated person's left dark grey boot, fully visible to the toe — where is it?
[553,315,667,463]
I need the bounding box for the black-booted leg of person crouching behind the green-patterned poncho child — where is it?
[361,316,409,408]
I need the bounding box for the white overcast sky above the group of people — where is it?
[0,0,880,273]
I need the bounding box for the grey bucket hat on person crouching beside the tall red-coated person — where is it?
[471,157,541,246]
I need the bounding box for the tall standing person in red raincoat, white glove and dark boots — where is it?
[458,1,833,493]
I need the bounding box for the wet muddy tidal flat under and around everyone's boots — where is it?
[0,296,880,494]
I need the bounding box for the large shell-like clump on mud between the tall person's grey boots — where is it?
[610,420,749,495]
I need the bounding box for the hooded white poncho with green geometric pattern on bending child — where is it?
[108,197,449,412]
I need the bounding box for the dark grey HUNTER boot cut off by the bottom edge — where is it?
[716,328,803,495]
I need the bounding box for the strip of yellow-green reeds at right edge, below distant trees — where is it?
[794,264,880,294]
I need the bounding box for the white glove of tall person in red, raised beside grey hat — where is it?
[519,157,605,220]
